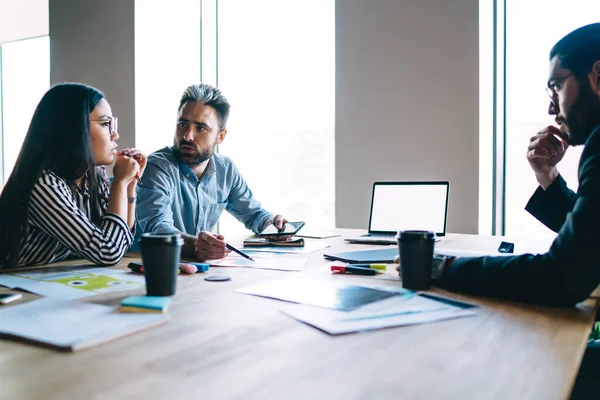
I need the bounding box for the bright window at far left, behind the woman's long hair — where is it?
[0,36,50,188]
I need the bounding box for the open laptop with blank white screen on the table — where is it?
[344,182,450,244]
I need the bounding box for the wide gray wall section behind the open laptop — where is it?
[335,0,478,233]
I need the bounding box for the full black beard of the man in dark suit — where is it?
[565,82,600,146]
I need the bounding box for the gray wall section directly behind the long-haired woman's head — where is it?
[49,0,135,148]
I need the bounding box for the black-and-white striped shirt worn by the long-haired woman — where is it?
[10,168,133,266]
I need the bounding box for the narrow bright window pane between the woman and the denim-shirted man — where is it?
[134,0,201,154]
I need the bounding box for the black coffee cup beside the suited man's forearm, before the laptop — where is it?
[397,231,435,290]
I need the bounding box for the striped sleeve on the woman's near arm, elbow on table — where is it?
[29,173,133,265]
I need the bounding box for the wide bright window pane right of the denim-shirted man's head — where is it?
[217,0,335,236]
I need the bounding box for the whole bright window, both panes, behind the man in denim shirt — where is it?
[135,0,335,236]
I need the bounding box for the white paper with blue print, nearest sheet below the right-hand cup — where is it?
[280,293,477,335]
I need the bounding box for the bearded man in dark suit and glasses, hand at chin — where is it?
[433,23,600,399]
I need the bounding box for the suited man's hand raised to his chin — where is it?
[527,125,569,190]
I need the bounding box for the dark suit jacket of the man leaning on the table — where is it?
[439,126,600,307]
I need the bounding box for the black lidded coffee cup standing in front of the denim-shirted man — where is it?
[140,233,183,296]
